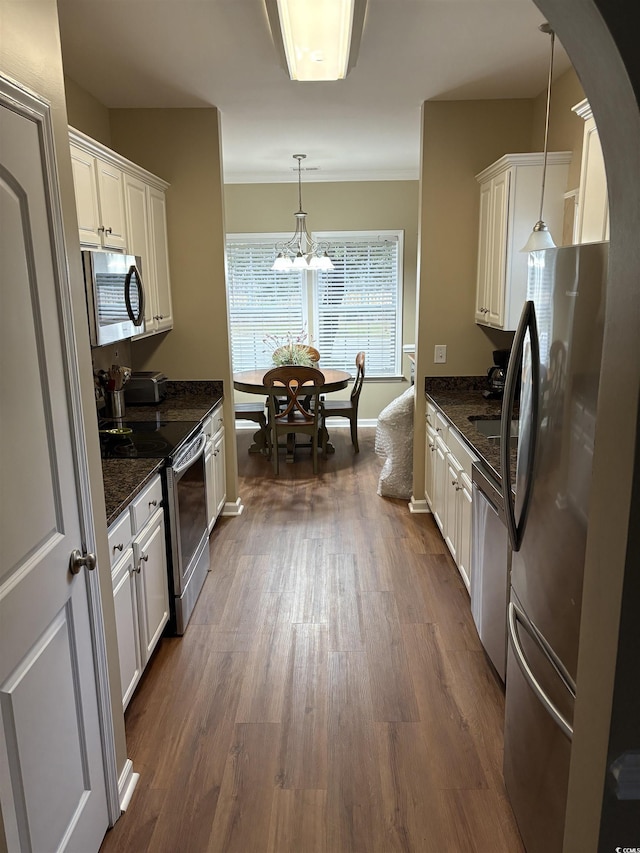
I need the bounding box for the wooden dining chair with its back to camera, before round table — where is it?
[262,364,324,474]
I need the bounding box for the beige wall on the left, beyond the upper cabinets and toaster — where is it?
[109,107,238,501]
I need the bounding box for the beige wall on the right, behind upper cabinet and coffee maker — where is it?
[414,77,584,498]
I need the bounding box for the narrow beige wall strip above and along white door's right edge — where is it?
[0,0,127,816]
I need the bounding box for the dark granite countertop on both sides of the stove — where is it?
[102,381,222,526]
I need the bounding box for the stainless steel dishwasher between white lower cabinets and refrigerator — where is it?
[470,462,511,681]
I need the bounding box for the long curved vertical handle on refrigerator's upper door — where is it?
[500,300,540,551]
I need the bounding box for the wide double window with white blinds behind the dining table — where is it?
[227,231,403,378]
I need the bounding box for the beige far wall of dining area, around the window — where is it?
[225,177,418,418]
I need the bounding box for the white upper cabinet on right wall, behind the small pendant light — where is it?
[475,151,571,331]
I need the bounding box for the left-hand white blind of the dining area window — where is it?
[227,234,306,371]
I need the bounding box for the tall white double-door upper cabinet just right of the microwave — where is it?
[124,174,173,337]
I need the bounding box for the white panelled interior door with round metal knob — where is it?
[0,78,108,853]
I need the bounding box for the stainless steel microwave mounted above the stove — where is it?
[82,251,145,347]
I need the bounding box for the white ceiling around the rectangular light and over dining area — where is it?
[58,0,570,183]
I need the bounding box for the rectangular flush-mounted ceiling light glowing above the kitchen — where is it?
[265,0,367,82]
